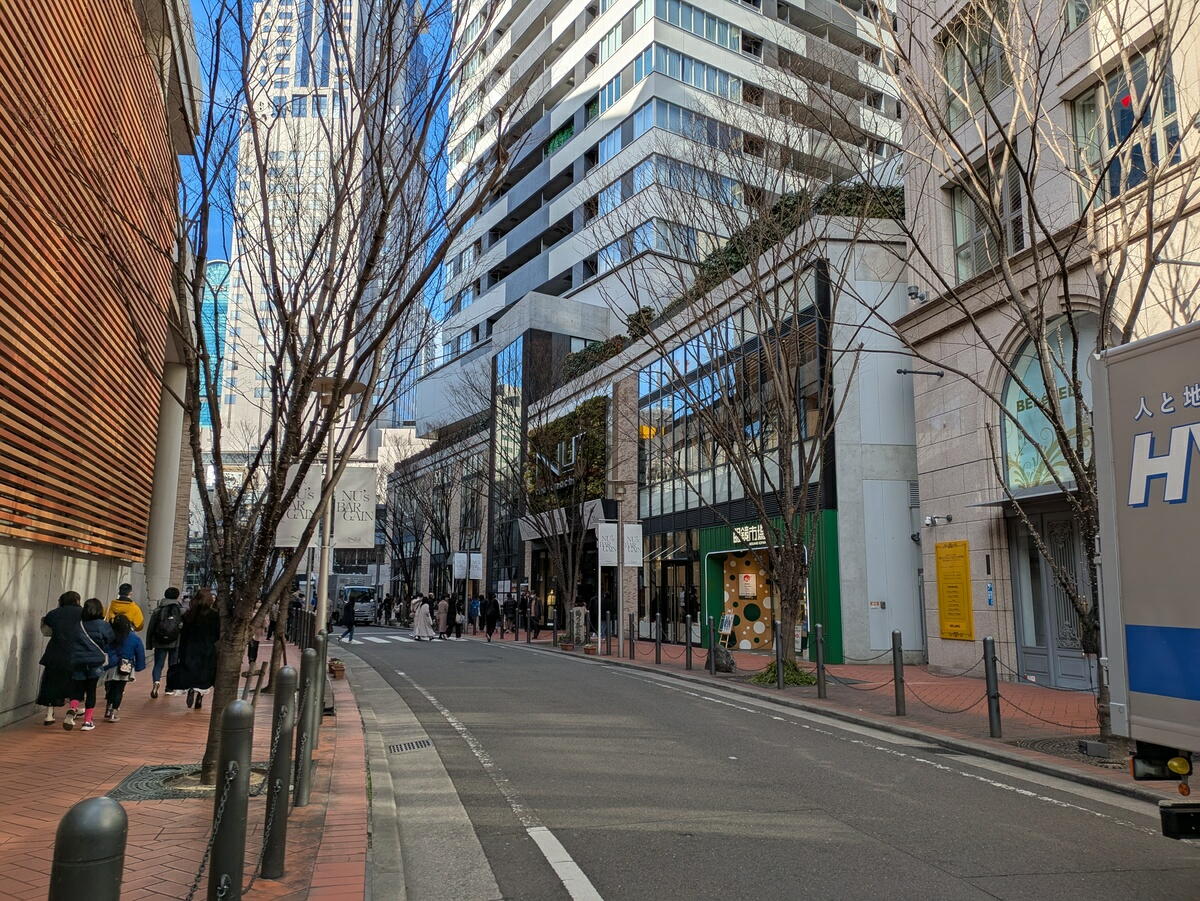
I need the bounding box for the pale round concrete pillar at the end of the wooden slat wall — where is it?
[145,362,187,605]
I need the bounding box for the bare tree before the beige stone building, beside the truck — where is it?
[844,0,1200,735]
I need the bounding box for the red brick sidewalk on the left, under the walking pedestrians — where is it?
[0,645,367,901]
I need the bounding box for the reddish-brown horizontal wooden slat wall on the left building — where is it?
[0,0,175,560]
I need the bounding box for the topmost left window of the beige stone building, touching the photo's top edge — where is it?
[938,0,1013,128]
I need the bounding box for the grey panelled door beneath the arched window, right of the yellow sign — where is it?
[1009,512,1093,689]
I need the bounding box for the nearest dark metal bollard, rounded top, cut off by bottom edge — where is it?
[49,798,130,901]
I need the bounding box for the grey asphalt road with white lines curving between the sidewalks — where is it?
[343,629,1200,901]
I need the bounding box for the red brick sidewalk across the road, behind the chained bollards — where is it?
[469,631,1178,798]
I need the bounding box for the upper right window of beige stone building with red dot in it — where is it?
[1072,56,1181,203]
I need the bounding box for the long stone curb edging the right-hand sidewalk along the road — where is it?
[508,642,1165,805]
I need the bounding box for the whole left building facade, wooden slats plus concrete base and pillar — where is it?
[0,0,197,723]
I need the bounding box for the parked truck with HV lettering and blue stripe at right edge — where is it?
[1092,323,1200,839]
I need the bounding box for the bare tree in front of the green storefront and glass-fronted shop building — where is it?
[583,100,902,663]
